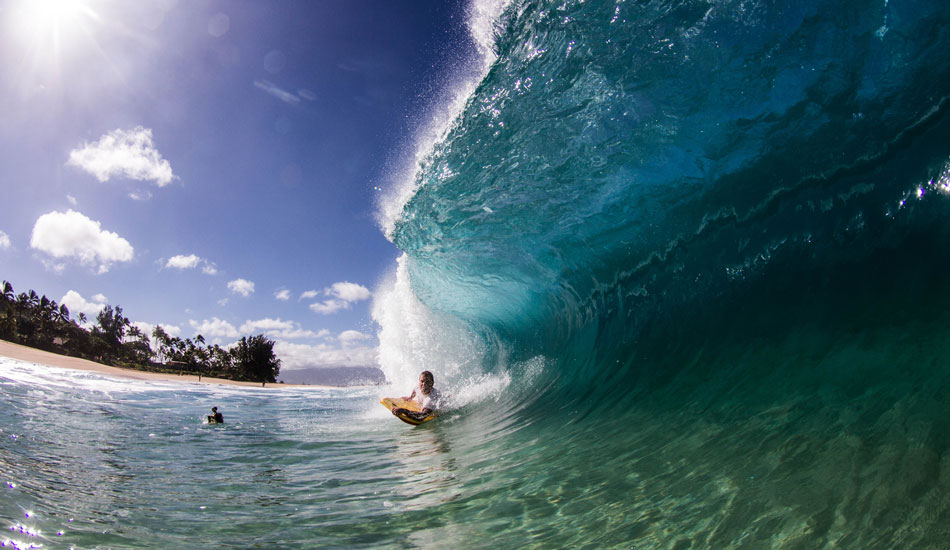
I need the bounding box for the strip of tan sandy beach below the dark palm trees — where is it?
[0,340,335,389]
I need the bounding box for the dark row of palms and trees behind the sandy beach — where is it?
[0,281,280,382]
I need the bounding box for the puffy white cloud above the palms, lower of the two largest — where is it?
[30,210,134,273]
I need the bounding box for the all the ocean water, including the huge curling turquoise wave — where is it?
[0,0,950,550]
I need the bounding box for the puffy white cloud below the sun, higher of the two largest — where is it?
[66,126,176,187]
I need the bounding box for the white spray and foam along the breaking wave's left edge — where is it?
[372,0,510,407]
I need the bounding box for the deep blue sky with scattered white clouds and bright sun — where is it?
[0,0,473,376]
